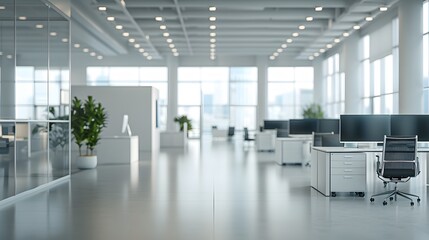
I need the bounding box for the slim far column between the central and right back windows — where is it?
[255,57,268,129]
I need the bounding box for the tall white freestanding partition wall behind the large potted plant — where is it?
[71,86,159,151]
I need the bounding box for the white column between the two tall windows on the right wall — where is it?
[340,34,363,113]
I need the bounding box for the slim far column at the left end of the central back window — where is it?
[167,56,179,131]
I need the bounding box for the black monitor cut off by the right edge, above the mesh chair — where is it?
[390,115,429,142]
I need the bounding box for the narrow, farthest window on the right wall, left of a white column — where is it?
[323,54,345,118]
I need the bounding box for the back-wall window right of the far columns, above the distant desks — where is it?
[267,67,313,120]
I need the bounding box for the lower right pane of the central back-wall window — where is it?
[230,107,256,131]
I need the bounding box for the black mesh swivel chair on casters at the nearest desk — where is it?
[370,136,420,206]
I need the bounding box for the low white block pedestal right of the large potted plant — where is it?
[97,136,139,164]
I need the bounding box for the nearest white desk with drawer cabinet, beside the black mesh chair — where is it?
[311,147,429,197]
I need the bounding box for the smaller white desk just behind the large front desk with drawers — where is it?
[275,136,312,165]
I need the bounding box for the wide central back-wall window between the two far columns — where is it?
[178,67,257,137]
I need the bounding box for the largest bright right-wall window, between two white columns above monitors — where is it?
[361,19,399,114]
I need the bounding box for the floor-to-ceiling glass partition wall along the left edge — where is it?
[0,0,70,200]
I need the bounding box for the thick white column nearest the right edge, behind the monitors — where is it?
[398,0,423,113]
